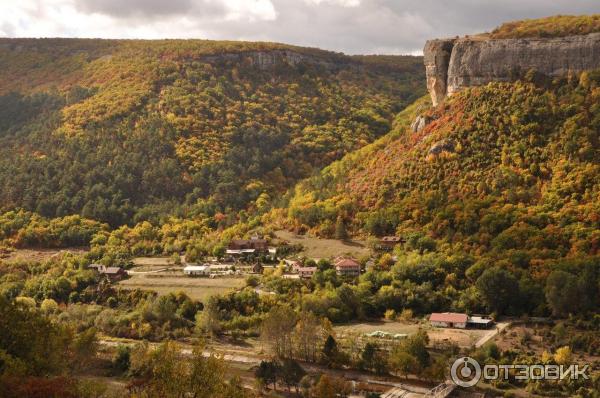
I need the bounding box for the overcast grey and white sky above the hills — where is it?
[0,0,600,54]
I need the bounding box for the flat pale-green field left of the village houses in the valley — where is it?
[118,274,245,301]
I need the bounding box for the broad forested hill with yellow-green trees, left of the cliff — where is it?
[0,39,424,226]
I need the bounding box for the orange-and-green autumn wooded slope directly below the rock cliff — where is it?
[288,72,600,270]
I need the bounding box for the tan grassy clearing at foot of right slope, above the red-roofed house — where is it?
[275,230,369,258]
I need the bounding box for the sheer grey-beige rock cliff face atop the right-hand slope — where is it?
[423,33,600,105]
